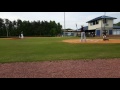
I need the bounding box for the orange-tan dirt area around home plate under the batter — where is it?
[63,39,120,44]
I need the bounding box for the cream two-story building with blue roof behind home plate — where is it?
[87,15,120,36]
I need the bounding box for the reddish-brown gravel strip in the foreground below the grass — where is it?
[0,59,120,78]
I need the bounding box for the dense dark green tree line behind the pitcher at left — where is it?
[0,18,63,37]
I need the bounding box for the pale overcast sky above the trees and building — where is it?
[0,12,120,29]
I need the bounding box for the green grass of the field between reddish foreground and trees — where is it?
[0,37,120,63]
